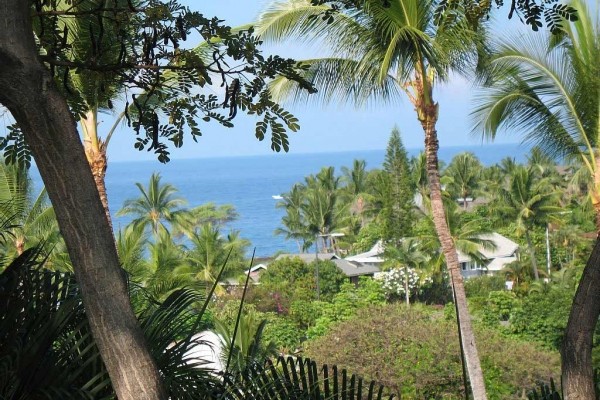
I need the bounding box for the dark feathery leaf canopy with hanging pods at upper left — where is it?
[0,0,314,165]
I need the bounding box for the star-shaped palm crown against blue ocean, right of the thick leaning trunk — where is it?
[117,173,189,238]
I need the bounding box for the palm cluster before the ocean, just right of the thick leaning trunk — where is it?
[117,173,250,298]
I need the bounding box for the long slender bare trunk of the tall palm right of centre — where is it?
[414,67,487,400]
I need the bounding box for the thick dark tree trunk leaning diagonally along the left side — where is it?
[0,0,167,400]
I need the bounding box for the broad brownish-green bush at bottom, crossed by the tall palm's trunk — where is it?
[305,304,559,399]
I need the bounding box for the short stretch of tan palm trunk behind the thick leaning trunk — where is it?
[80,110,113,230]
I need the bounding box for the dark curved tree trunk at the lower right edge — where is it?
[561,238,600,400]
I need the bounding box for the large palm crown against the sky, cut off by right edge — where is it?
[473,0,600,227]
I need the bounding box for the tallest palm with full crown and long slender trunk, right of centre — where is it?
[257,0,487,399]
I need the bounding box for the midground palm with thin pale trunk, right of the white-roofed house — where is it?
[494,166,562,281]
